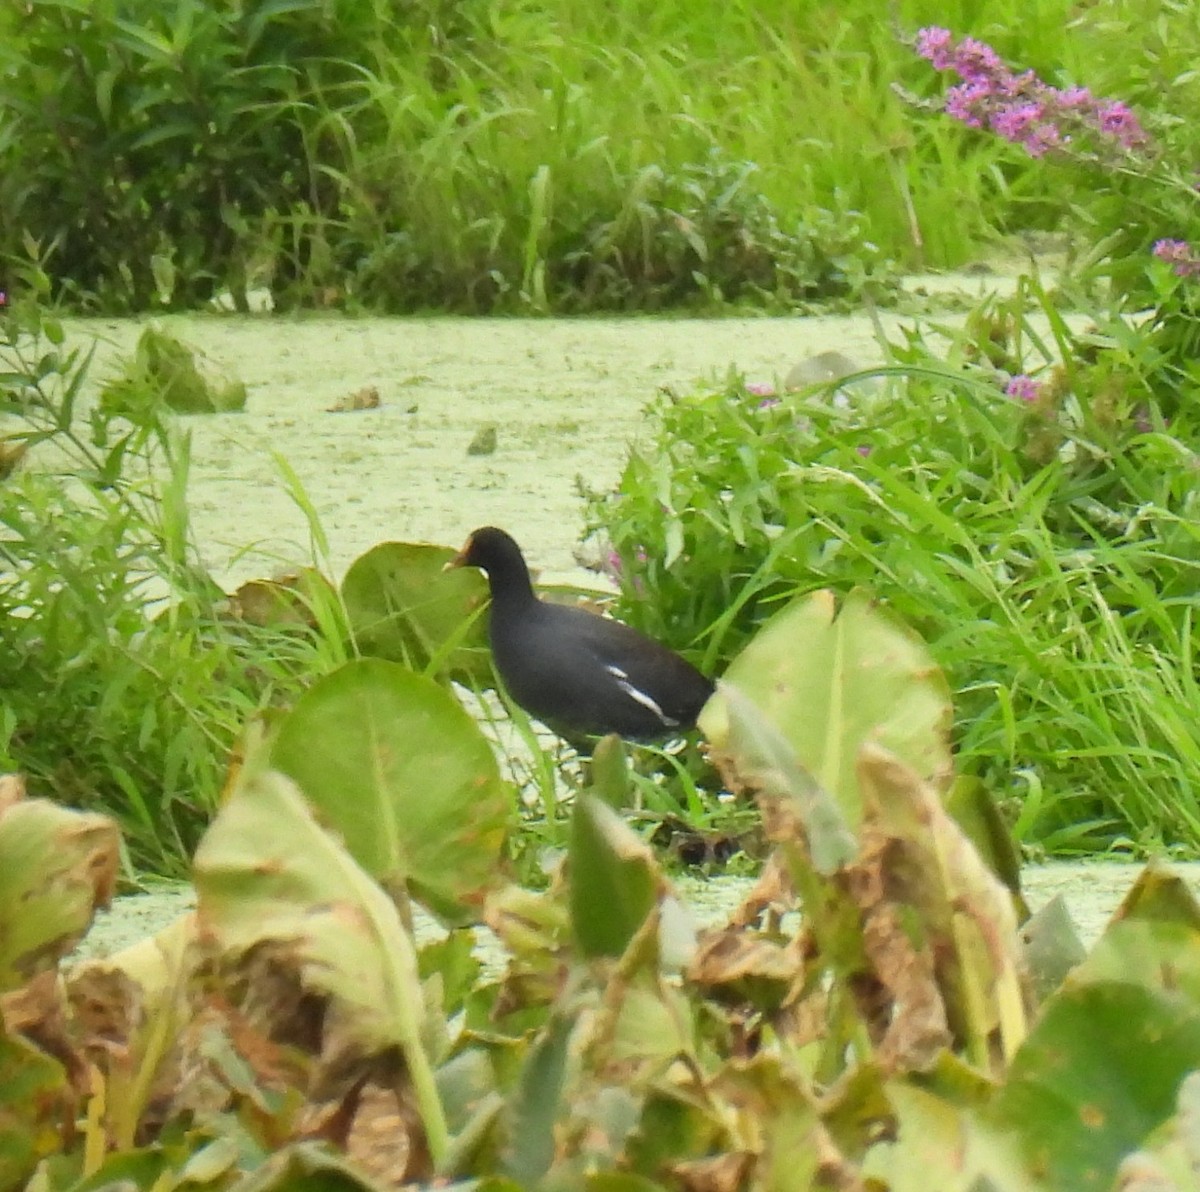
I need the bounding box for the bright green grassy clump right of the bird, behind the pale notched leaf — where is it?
[588,272,1200,850]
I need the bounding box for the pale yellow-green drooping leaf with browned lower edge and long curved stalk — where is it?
[194,766,446,1162]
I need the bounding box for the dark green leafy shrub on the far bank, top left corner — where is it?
[0,0,408,310]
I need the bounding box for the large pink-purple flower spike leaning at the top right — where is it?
[917,26,1150,157]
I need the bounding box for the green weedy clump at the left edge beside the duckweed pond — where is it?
[0,292,328,874]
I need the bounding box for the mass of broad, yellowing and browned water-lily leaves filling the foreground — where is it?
[7,593,1200,1192]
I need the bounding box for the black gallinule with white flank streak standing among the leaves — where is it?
[449,526,713,741]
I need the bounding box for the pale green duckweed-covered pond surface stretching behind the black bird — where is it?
[68,275,1012,587]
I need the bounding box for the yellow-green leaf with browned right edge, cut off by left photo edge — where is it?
[0,774,120,992]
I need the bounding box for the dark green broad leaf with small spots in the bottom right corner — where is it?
[985,975,1200,1192]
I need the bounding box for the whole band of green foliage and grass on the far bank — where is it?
[0,0,1200,312]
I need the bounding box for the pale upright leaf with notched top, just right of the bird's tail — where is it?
[700,591,952,827]
